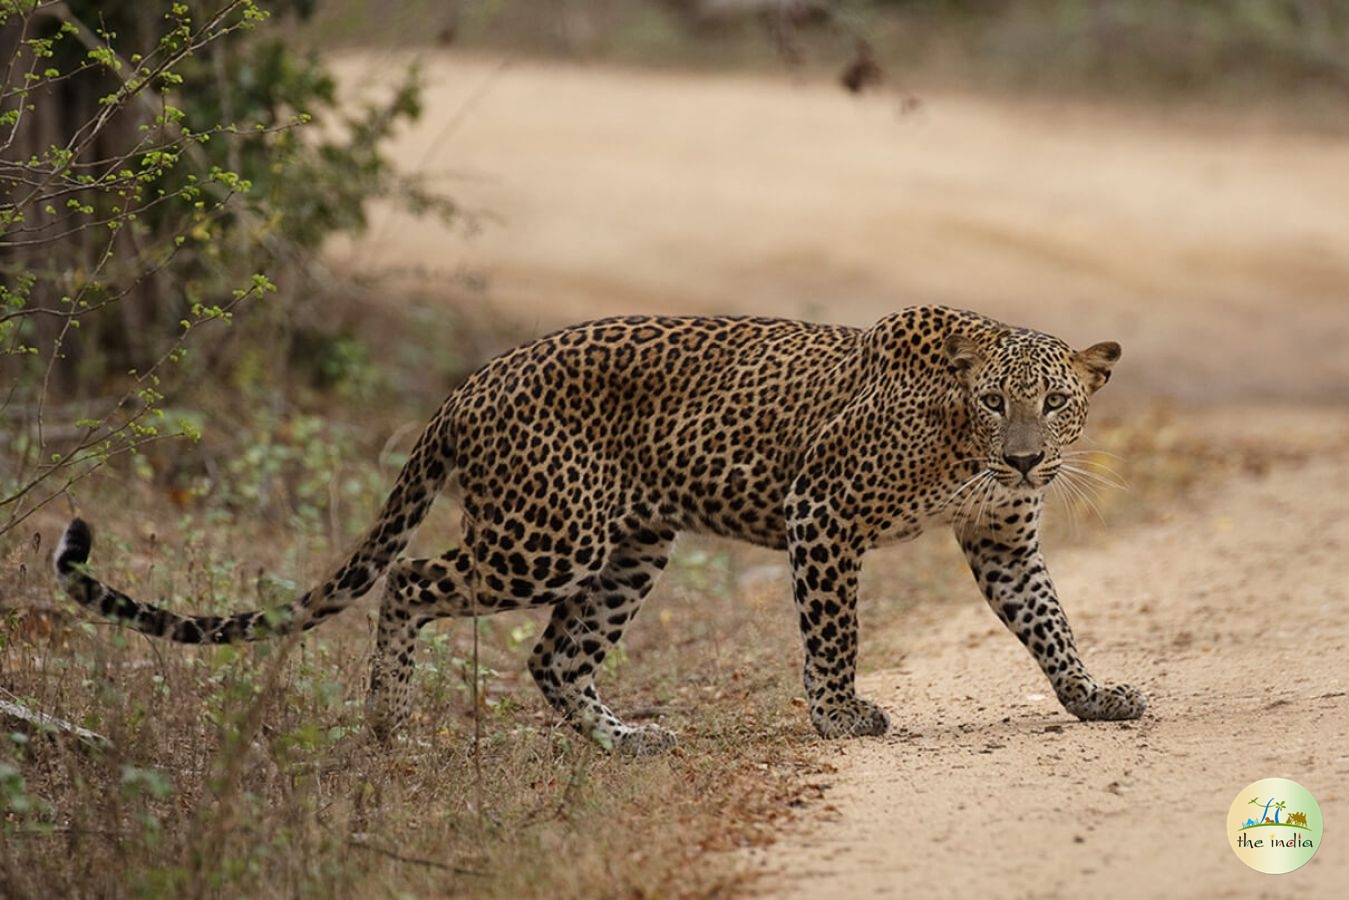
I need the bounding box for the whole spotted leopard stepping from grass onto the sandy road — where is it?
[54,305,1148,754]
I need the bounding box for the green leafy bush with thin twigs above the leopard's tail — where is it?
[0,0,453,534]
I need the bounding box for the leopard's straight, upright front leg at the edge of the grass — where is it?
[786,493,890,738]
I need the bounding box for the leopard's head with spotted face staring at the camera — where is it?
[946,329,1120,491]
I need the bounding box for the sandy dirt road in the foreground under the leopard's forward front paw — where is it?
[746,445,1349,899]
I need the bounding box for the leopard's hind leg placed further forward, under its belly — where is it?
[529,524,675,754]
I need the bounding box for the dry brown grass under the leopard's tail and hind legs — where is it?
[0,497,841,897]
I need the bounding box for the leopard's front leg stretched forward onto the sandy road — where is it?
[956,501,1148,721]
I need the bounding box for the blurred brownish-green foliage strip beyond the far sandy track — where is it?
[309,0,1349,99]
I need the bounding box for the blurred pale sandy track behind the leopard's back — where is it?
[333,57,1349,402]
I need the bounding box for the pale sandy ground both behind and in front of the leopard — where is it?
[332,57,1349,897]
